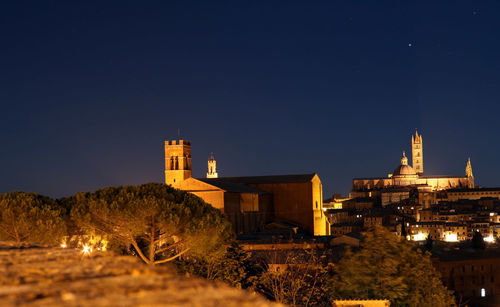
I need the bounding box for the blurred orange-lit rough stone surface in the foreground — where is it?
[0,242,282,307]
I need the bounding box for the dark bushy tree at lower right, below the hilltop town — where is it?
[330,226,455,307]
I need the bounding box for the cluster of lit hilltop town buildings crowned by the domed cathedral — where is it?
[325,133,500,243]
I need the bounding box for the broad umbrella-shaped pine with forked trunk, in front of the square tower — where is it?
[62,184,231,264]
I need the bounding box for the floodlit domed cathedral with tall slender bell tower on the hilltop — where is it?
[350,132,474,204]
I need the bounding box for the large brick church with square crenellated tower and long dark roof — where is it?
[165,140,330,235]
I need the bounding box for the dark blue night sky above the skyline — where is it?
[0,1,500,198]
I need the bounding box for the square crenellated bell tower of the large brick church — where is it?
[165,140,192,186]
